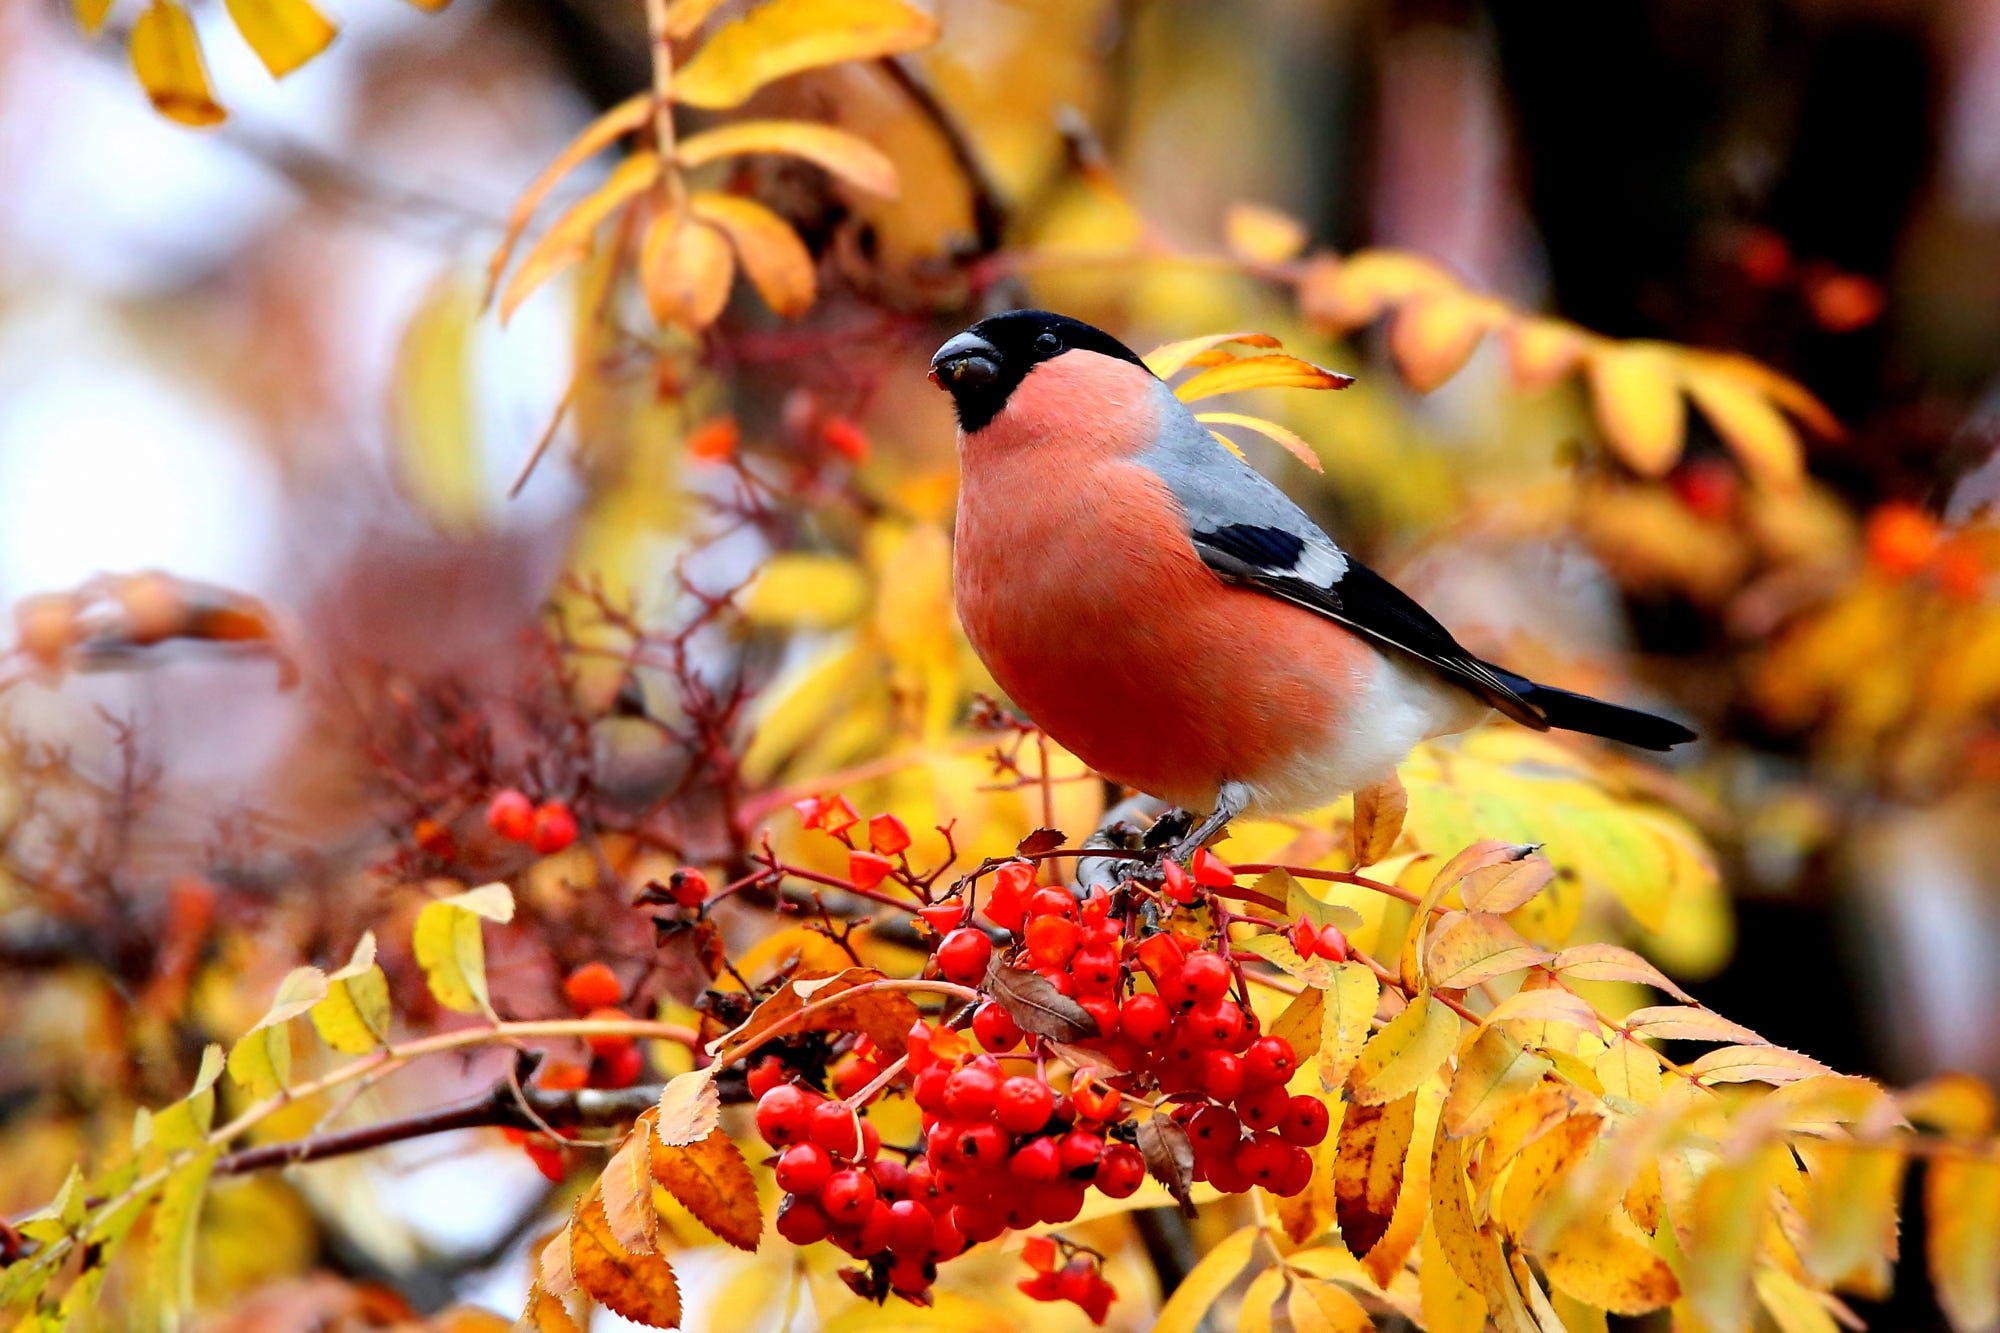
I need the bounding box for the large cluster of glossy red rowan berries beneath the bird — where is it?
[750,840,1346,1323]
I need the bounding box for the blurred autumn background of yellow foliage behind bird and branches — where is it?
[0,0,2000,1329]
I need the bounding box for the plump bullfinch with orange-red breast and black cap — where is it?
[930,310,1694,851]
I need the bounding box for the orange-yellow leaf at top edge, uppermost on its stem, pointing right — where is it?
[674,0,938,110]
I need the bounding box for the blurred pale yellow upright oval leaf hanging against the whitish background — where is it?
[390,272,486,534]
